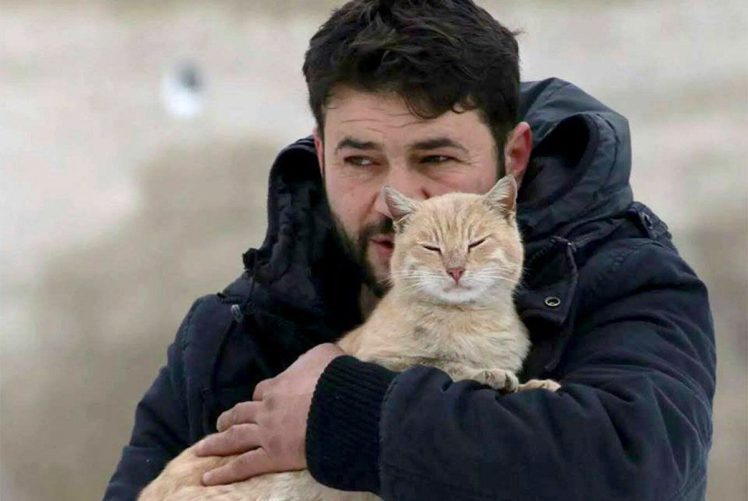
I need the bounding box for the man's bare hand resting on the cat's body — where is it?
[195,343,345,485]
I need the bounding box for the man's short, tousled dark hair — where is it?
[303,0,519,163]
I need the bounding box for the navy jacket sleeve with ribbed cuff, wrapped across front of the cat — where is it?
[307,241,715,501]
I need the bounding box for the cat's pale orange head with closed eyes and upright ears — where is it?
[385,176,523,304]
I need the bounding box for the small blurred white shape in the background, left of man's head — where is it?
[161,61,204,119]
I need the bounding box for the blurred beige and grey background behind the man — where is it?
[0,0,748,501]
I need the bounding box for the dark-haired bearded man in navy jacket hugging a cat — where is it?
[106,0,715,500]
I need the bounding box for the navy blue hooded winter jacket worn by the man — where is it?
[105,79,715,501]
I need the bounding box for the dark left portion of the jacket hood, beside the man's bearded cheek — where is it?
[228,136,362,332]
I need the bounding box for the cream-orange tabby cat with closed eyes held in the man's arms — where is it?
[140,176,559,501]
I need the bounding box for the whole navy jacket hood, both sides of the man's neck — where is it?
[229,79,632,332]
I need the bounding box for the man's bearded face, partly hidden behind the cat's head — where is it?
[315,87,528,295]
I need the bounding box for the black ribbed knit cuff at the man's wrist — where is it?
[306,355,397,493]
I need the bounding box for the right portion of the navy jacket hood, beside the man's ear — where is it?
[517,79,633,242]
